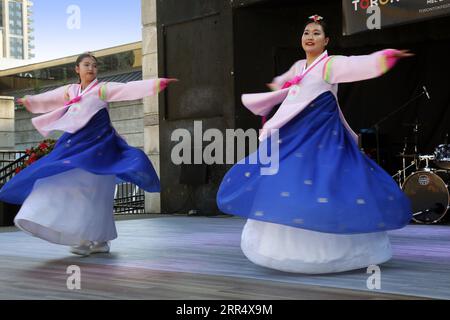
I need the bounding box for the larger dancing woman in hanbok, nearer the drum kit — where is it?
[217,15,412,274]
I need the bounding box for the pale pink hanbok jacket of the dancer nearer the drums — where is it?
[242,49,398,141]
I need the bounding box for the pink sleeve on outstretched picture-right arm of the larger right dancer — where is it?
[323,49,399,84]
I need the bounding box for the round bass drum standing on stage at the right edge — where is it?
[402,170,450,224]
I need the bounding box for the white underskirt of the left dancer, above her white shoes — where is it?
[14,169,117,245]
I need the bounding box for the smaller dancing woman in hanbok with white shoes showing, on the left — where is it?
[0,53,174,255]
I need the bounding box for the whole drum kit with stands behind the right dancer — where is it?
[393,123,450,224]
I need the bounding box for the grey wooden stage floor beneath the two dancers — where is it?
[0,216,450,300]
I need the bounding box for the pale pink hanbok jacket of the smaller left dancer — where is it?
[23,78,168,137]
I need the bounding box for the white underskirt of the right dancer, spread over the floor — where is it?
[241,219,392,274]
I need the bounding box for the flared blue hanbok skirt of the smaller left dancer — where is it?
[0,109,160,204]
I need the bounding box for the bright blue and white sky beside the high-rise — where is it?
[31,0,142,62]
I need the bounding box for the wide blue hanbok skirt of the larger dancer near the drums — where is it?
[217,92,412,234]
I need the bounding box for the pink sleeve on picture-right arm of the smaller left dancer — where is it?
[98,78,168,102]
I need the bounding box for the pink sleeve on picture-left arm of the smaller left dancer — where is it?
[22,85,70,113]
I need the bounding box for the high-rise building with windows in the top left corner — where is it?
[0,0,34,60]
